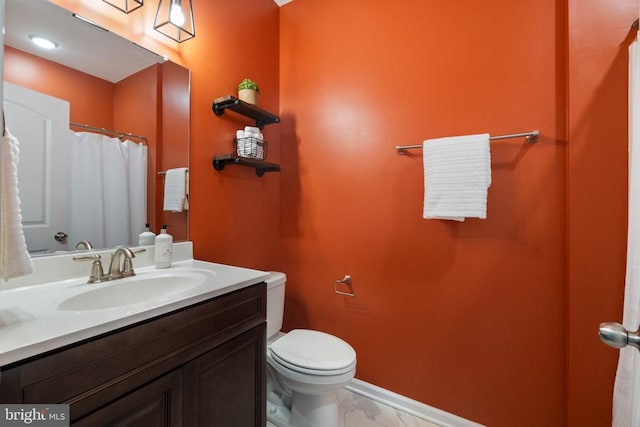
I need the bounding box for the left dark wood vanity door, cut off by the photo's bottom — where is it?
[71,369,182,427]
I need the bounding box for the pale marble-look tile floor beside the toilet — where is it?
[267,389,440,427]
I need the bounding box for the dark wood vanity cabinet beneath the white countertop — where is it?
[0,283,266,427]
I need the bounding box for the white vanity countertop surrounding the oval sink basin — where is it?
[0,244,269,367]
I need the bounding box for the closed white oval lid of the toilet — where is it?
[271,329,356,371]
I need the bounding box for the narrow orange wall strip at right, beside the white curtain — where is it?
[567,0,638,427]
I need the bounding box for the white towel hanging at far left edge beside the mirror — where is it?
[0,130,33,280]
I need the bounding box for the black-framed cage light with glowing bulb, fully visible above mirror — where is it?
[153,0,196,43]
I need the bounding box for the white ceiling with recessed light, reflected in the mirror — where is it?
[4,0,164,83]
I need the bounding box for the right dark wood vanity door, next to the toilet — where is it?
[183,323,266,427]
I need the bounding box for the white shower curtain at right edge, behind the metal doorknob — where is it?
[613,34,640,427]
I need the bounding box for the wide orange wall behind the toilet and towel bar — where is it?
[277,0,566,427]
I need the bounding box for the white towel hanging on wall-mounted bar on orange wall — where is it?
[423,134,491,221]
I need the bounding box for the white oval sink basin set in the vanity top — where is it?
[58,271,209,311]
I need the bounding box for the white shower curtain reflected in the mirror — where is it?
[69,132,147,248]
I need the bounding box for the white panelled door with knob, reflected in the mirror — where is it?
[3,82,70,254]
